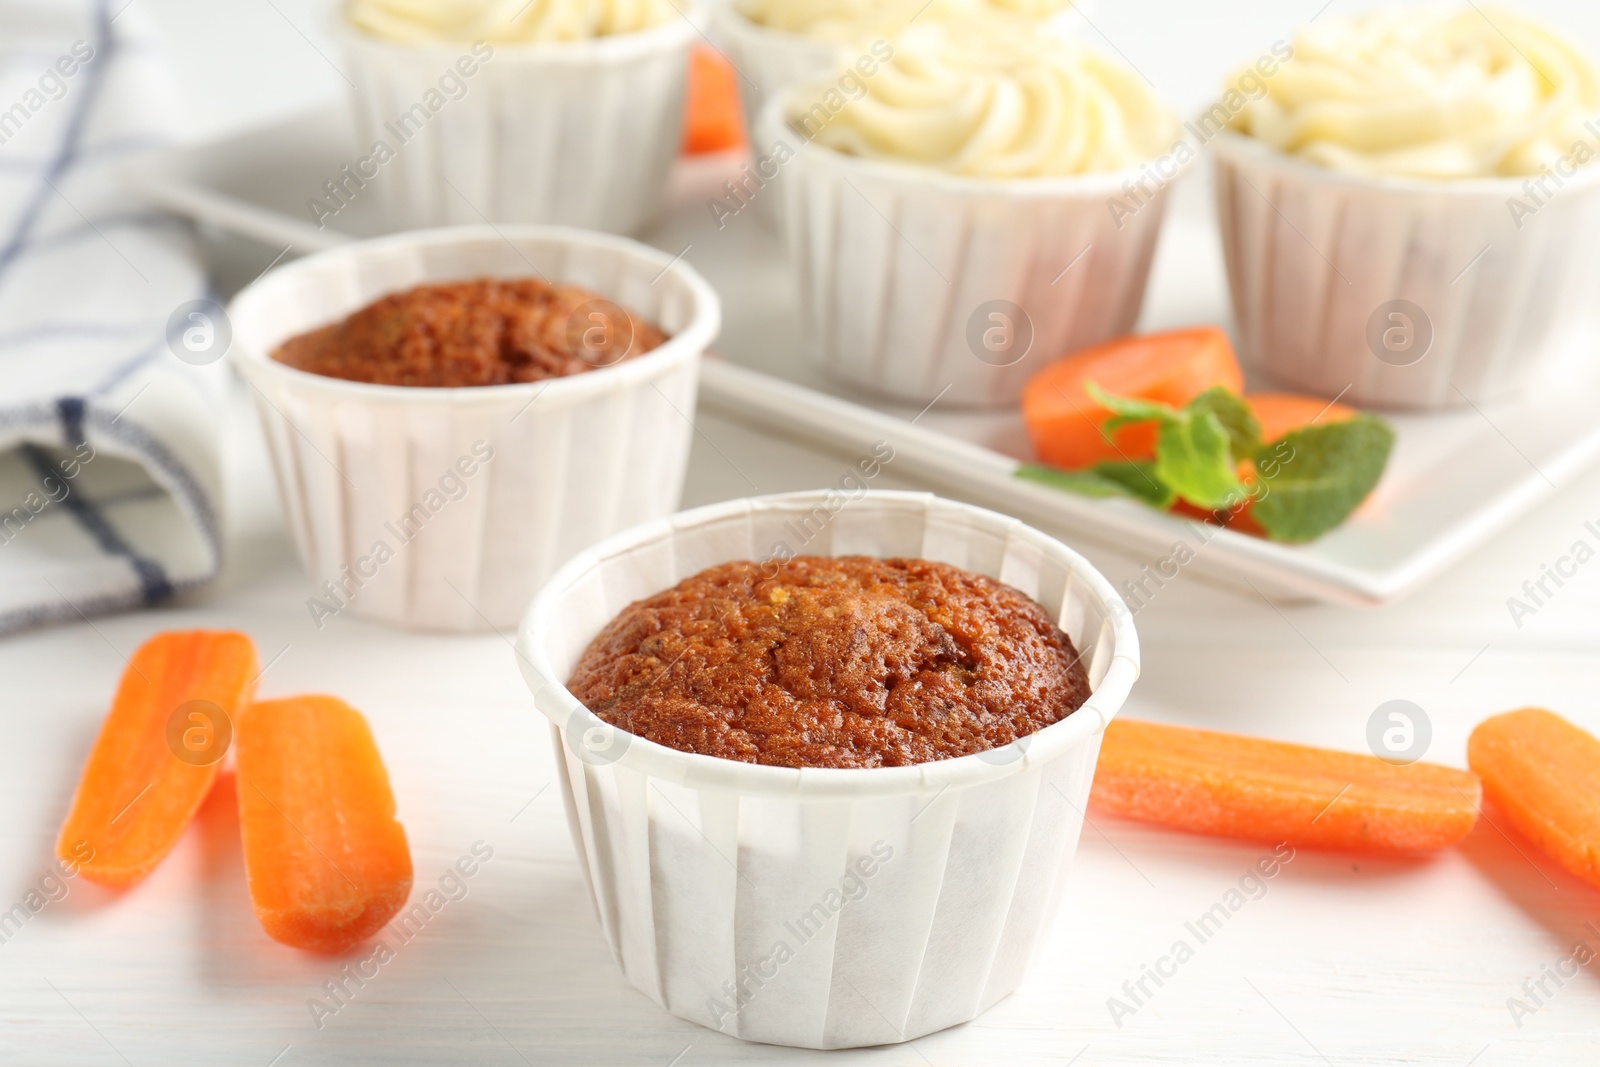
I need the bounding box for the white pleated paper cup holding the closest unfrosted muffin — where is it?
[518,493,1139,1048]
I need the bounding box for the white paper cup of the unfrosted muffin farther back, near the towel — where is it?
[229,226,722,630]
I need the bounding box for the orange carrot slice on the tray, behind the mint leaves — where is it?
[1022,326,1245,470]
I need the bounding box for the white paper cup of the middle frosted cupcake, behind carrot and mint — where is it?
[762,96,1182,408]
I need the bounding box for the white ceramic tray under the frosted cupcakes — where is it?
[128,109,1600,605]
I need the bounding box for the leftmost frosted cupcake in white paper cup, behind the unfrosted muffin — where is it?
[342,0,698,234]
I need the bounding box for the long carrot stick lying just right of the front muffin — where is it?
[1090,718,1480,849]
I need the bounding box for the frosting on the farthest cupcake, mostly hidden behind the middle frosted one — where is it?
[734,0,1072,43]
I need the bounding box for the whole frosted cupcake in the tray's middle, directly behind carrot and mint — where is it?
[757,18,1195,406]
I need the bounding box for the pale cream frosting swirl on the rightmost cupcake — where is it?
[1234,6,1600,179]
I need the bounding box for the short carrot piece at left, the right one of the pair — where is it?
[237,696,411,952]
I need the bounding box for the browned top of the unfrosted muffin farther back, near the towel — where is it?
[272,278,667,387]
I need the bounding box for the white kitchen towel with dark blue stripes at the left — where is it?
[0,0,227,633]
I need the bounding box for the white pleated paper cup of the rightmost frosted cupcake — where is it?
[1211,133,1600,408]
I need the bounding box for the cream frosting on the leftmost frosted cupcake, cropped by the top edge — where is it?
[344,0,677,45]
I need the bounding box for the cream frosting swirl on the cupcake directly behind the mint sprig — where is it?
[786,18,1178,178]
